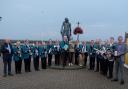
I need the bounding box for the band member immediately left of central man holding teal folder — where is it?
[54,41,60,66]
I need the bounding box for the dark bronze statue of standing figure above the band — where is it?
[61,18,71,41]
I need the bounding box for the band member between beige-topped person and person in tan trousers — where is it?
[74,40,81,65]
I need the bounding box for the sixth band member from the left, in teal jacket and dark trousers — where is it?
[47,39,54,67]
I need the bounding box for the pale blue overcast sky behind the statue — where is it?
[0,0,128,40]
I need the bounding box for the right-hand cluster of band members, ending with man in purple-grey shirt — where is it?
[85,36,127,84]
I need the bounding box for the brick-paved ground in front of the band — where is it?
[0,57,128,89]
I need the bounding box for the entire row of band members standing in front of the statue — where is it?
[1,36,127,84]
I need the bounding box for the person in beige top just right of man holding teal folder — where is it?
[69,41,75,66]
